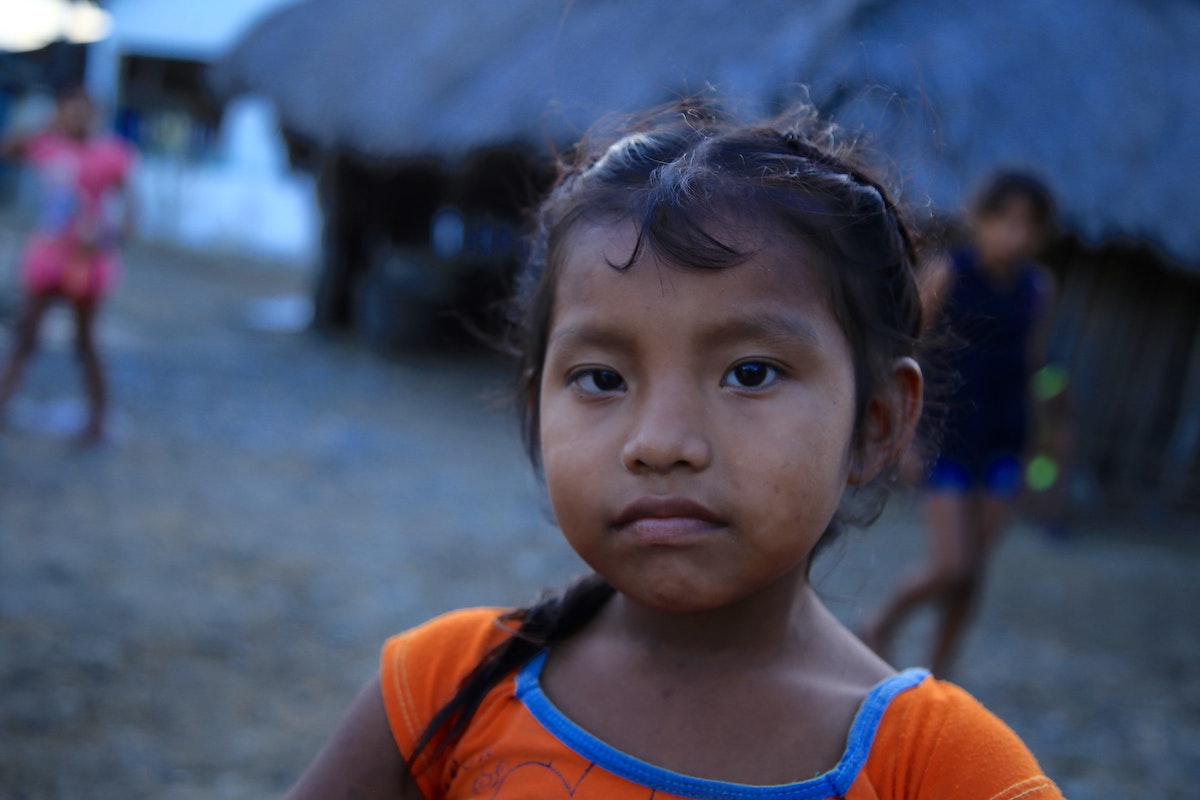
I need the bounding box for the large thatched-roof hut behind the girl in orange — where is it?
[225,0,1200,505]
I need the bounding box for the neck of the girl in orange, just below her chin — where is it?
[604,573,823,663]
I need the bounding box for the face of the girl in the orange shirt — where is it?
[540,224,856,610]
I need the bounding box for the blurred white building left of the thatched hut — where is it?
[86,0,320,264]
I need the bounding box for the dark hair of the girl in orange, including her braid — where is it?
[410,104,922,769]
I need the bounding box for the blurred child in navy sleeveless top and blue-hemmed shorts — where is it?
[864,172,1054,676]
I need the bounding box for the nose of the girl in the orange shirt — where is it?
[620,392,713,475]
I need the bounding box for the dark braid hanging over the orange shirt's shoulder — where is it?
[409,573,614,774]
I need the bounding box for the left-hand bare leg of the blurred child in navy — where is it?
[863,491,970,657]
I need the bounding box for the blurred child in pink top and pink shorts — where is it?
[0,88,132,443]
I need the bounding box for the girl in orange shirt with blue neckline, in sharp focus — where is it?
[288,110,1060,800]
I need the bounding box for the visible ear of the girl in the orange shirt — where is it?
[846,357,924,486]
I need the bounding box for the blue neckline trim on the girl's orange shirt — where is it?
[516,650,929,800]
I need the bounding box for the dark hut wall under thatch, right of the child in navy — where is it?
[1050,246,1200,509]
